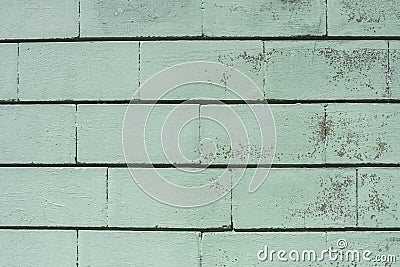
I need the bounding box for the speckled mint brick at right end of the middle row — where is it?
[326,103,400,163]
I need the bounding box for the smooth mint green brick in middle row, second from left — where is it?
[77,104,199,164]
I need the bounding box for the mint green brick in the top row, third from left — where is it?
[203,0,326,37]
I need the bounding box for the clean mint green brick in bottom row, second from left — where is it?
[78,231,200,267]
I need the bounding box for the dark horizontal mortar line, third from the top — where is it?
[0,163,400,169]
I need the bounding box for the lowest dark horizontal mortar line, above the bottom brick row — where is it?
[0,226,400,233]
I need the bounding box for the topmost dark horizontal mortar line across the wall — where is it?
[0,35,400,43]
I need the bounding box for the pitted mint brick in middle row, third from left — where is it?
[200,104,324,164]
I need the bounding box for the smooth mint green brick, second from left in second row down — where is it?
[19,42,139,100]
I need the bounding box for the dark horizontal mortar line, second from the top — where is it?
[0,99,400,105]
